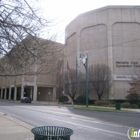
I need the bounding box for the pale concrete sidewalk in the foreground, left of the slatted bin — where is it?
[0,113,34,140]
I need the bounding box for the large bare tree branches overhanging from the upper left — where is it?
[0,0,62,76]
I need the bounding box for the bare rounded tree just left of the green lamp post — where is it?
[64,69,81,101]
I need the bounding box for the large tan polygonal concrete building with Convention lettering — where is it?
[65,6,140,99]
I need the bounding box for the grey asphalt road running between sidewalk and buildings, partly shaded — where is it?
[0,100,140,140]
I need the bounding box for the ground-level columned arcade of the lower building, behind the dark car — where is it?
[0,71,58,101]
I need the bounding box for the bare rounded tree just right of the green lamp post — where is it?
[89,64,111,100]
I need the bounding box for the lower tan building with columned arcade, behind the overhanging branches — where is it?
[0,37,64,101]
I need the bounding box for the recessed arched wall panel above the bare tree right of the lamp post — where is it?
[80,24,108,65]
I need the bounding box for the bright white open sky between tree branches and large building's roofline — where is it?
[31,0,140,43]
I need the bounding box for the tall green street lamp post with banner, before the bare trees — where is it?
[79,53,88,107]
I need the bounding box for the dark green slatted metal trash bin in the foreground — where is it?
[31,126,73,140]
